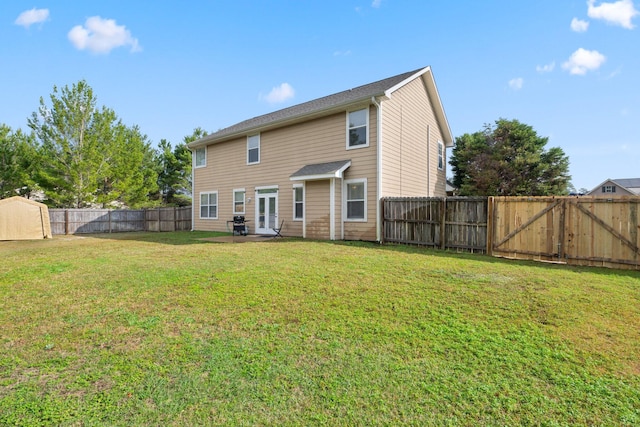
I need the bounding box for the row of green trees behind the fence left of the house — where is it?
[0,80,207,208]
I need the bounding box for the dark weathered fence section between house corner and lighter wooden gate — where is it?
[382,197,488,253]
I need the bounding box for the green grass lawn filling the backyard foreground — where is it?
[0,232,640,426]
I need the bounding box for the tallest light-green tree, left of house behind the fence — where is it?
[28,80,157,208]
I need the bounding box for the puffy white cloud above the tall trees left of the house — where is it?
[67,16,142,53]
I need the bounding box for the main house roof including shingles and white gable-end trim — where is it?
[188,67,453,149]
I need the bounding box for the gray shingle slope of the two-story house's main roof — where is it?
[189,68,425,147]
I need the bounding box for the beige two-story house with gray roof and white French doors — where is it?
[189,67,453,241]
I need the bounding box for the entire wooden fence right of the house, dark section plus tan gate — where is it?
[381,197,640,269]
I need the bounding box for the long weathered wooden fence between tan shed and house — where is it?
[49,206,191,234]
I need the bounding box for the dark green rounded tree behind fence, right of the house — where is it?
[449,119,571,196]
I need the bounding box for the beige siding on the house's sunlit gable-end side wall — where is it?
[381,79,447,196]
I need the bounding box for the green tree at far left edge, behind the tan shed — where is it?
[0,124,38,199]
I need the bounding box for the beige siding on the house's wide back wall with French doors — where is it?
[194,104,377,240]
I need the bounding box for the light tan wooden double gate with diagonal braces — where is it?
[489,197,640,269]
